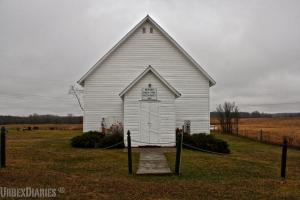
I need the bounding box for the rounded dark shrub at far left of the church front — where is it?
[71,131,104,148]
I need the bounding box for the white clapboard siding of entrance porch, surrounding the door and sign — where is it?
[124,72,176,146]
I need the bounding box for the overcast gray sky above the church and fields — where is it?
[0,0,300,115]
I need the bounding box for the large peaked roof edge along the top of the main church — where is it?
[77,15,216,86]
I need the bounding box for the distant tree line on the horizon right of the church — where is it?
[210,111,300,118]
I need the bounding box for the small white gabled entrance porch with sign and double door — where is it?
[120,66,180,146]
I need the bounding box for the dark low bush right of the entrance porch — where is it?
[183,133,230,153]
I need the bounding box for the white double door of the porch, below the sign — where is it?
[140,101,160,145]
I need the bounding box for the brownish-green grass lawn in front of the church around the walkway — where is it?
[0,131,300,200]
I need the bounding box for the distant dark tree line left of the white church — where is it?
[0,114,82,125]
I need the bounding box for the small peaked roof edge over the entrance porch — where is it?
[119,65,181,98]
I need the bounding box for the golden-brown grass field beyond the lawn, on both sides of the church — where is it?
[6,117,300,148]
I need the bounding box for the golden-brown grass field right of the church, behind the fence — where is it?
[211,117,300,147]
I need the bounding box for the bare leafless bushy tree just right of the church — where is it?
[216,102,240,133]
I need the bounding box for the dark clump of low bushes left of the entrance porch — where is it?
[71,131,124,148]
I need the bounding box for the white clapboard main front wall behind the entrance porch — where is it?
[83,21,209,133]
